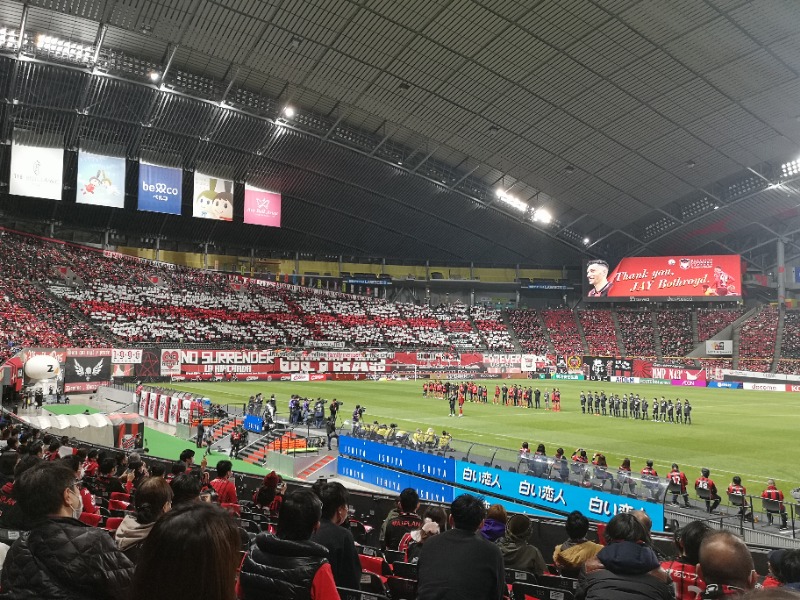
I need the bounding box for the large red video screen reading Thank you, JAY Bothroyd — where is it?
[583,254,742,302]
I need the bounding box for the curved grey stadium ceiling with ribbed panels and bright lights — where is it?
[0,0,800,269]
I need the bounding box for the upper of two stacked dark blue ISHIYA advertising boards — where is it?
[339,436,456,483]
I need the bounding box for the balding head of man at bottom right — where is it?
[697,531,758,598]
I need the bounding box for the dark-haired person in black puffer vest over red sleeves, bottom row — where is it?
[238,490,339,600]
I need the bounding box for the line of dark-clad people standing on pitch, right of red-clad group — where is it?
[580,391,692,425]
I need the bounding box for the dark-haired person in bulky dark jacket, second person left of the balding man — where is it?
[575,513,675,600]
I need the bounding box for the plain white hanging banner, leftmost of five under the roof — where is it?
[8,138,64,200]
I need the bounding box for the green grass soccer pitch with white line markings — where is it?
[171,379,800,497]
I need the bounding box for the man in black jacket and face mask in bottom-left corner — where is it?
[0,461,134,600]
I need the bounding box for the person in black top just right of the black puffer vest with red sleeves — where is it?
[311,481,361,590]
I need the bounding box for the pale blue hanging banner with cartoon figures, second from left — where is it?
[75,150,125,208]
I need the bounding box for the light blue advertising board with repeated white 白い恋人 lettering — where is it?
[455,461,664,530]
